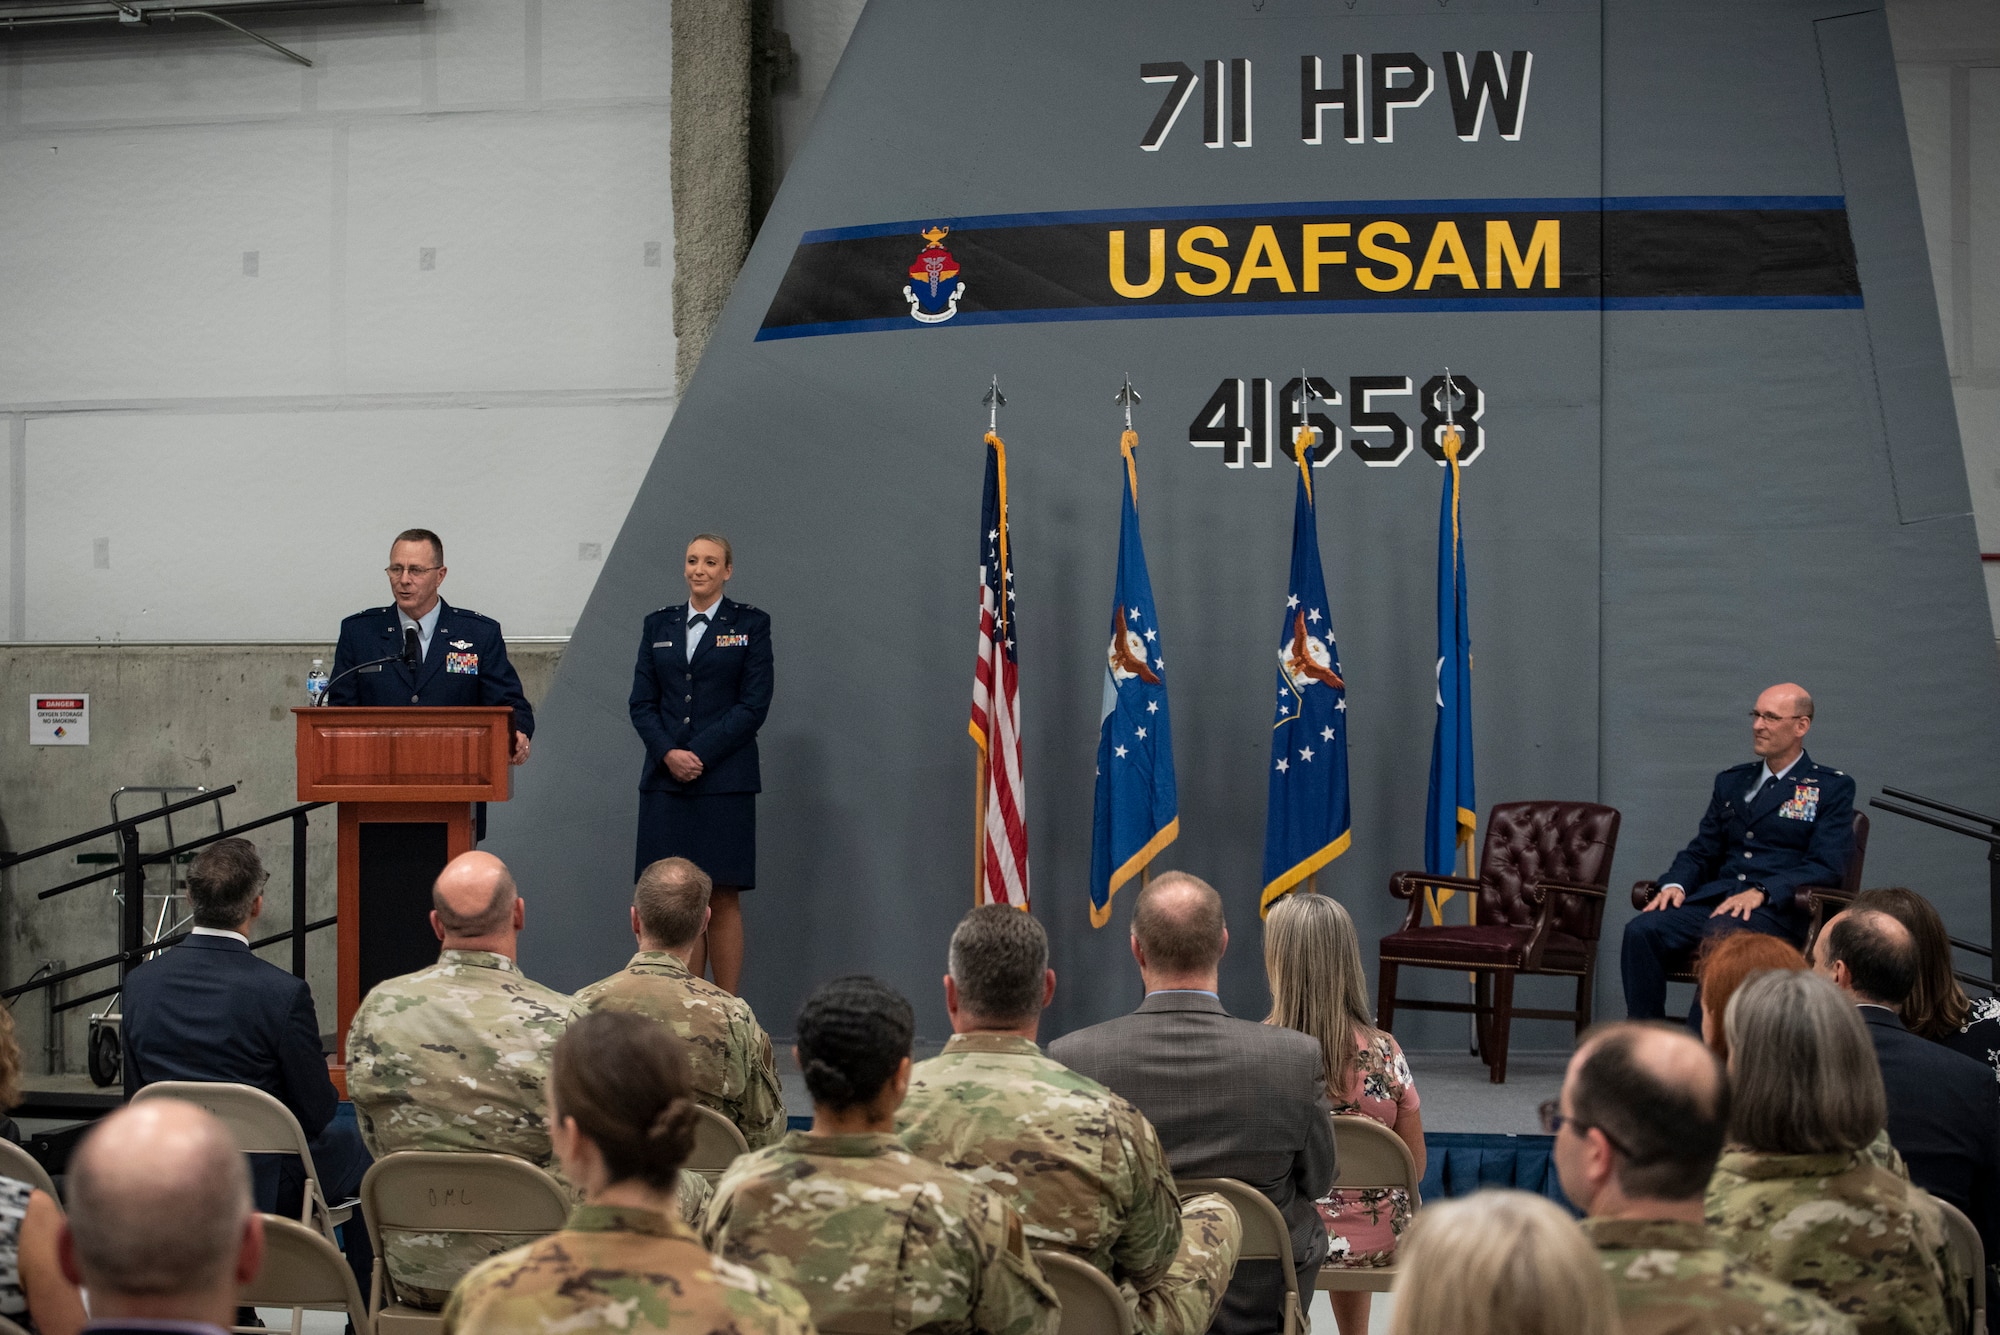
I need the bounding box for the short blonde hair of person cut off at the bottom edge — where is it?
[1388,1191,1618,1335]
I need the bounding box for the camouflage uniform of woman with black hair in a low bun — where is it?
[702,1131,1062,1335]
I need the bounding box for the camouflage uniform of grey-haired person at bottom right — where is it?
[1708,1149,1964,1335]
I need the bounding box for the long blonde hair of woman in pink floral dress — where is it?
[1264,893,1376,1103]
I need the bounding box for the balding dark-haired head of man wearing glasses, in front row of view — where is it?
[1562,1023,1730,1213]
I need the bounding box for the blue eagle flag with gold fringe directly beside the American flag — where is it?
[1090,430,1180,927]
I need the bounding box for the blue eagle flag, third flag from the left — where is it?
[1258,432,1354,913]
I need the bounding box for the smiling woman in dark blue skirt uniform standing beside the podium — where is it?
[632,534,772,993]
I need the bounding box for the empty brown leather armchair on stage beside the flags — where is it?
[1376,801,1620,1085]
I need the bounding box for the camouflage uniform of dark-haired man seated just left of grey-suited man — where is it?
[896,1033,1242,1335]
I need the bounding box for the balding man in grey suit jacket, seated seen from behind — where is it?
[1048,871,1334,1335]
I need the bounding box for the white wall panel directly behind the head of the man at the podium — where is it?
[26,404,668,640]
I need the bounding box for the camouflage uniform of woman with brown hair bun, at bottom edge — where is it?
[444,1205,812,1335]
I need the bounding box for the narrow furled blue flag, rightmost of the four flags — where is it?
[1424,425,1480,887]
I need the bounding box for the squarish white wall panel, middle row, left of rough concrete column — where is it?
[346,108,674,394]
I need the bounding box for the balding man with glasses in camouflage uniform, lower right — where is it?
[1542,1023,1854,1335]
